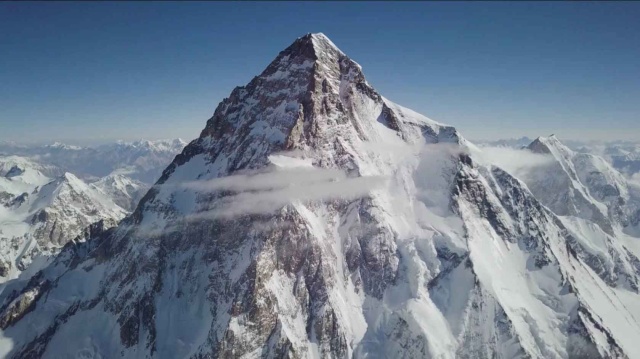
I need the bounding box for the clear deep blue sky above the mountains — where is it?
[0,2,640,142]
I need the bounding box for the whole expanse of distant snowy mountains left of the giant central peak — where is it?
[0,139,185,282]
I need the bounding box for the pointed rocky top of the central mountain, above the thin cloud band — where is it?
[166,34,464,191]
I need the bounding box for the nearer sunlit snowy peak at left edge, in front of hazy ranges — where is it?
[0,156,126,282]
